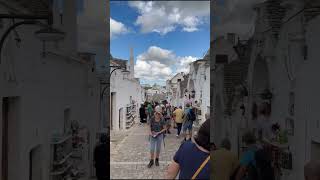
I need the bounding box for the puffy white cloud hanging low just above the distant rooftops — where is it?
[135,46,197,82]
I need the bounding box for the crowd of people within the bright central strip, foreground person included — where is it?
[139,101,211,179]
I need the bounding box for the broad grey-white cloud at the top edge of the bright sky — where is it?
[129,1,210,35]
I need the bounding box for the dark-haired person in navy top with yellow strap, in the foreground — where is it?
[167,120,210,179]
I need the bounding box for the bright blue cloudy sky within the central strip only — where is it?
[110,1,210,85]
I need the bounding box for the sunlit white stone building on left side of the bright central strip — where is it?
[110,50,145,130]
